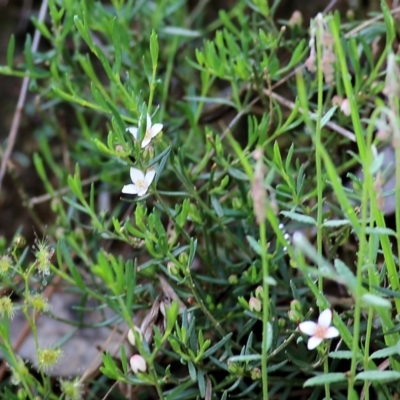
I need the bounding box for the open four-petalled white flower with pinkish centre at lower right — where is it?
[299,308,339,350]
